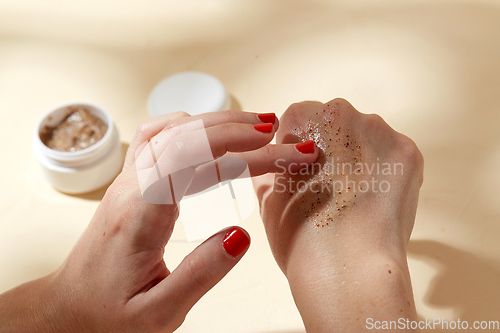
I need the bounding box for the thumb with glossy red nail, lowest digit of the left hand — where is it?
[150,227,250,318]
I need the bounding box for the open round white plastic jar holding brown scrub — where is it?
[33,103,123,194]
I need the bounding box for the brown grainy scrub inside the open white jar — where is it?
[40,107,108,152]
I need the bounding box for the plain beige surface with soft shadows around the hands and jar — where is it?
[0,0,500,333]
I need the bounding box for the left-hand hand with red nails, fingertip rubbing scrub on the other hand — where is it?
[0,111,318,333]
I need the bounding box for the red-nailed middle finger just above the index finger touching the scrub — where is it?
[135,120,274,204]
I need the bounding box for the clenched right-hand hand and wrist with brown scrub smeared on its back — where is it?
[254,99,423,332]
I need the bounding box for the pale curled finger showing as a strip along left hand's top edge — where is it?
[123,111,190,169]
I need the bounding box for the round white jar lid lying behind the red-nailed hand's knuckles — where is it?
[148,72,230,117]
